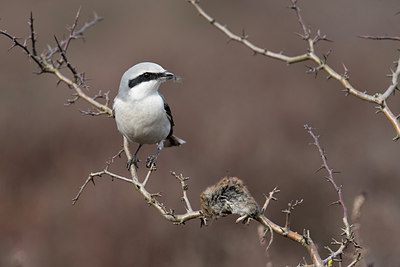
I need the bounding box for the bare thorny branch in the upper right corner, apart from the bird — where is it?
[187,0,400,141]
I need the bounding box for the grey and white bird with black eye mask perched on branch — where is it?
[113,62,186,170]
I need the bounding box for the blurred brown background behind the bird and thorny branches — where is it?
[0,0,400,266]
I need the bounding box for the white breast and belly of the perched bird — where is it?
[114,93,171,144]
